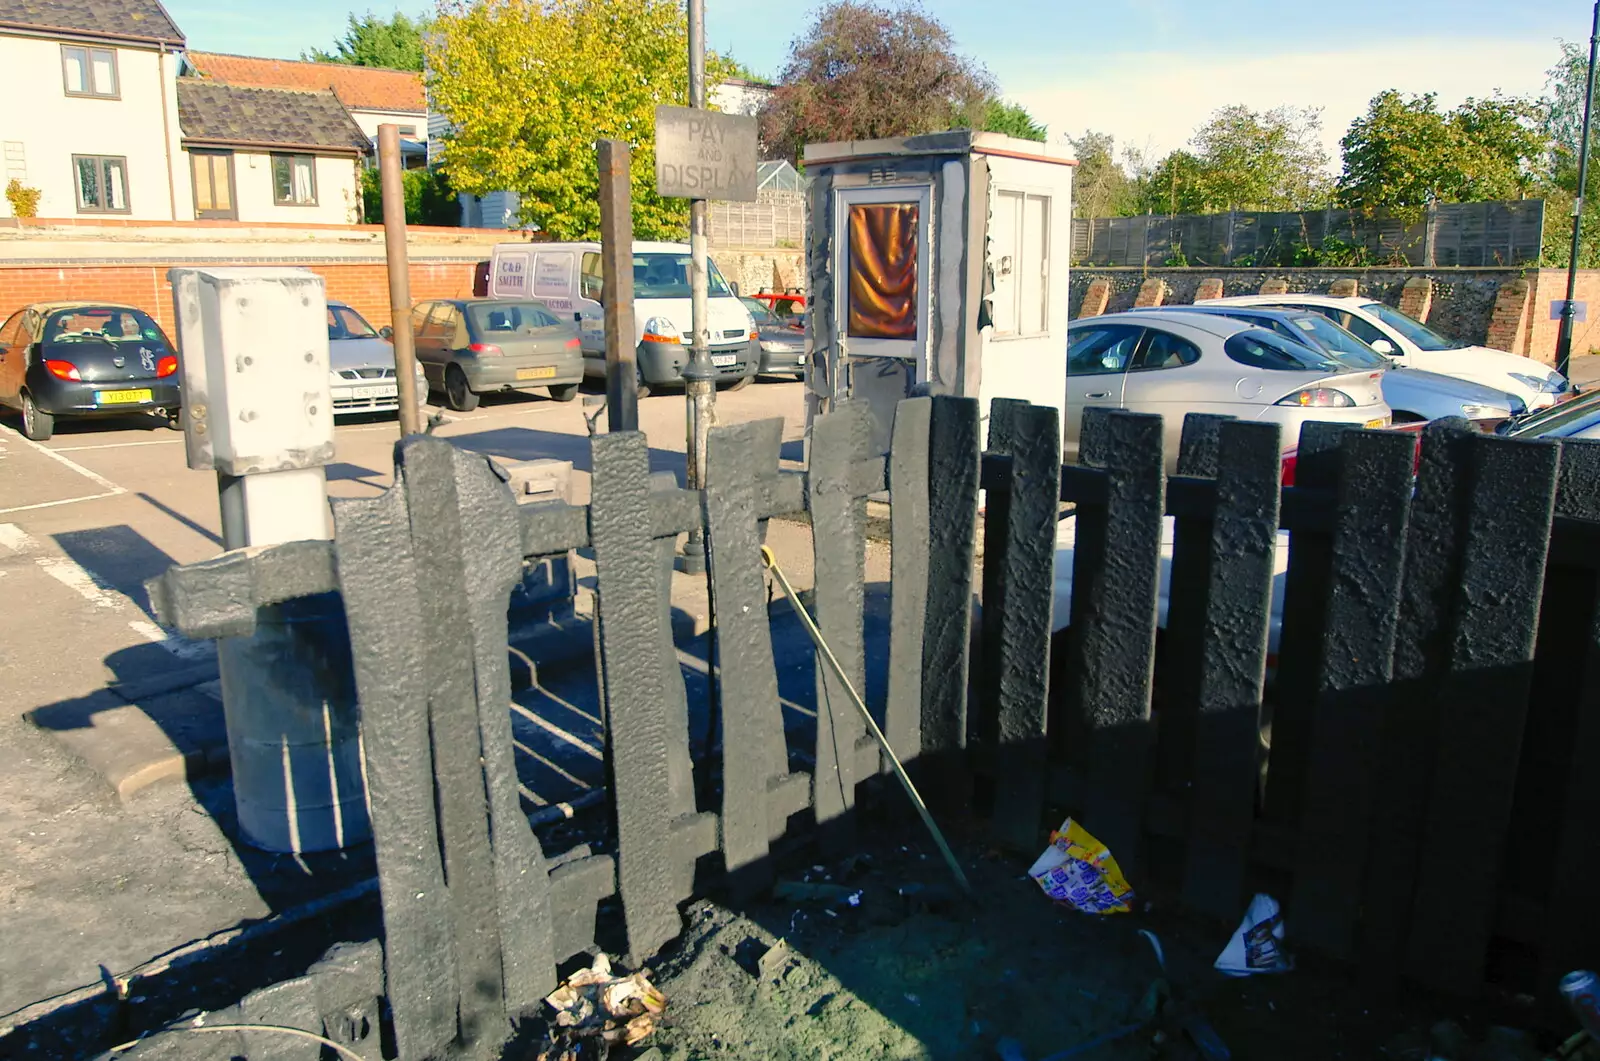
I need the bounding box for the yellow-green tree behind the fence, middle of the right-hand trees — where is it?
[1136,104,1330,214]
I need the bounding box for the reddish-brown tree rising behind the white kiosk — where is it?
[760,0,995,158]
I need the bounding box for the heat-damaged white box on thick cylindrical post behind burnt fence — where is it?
[168,269,371,853]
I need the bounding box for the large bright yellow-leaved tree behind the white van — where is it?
[427,0,726,240]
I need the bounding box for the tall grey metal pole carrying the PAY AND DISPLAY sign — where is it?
[683,0,717,573]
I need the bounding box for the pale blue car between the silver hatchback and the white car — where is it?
[1139,302,1528,430]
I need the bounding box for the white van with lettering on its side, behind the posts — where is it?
[488,242,762,387]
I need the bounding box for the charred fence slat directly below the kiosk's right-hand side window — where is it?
[984,400,1061,851]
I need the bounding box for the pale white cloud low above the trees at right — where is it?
[1005,38,1558,170]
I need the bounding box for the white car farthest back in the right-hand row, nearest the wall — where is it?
[1206,294,1573,410]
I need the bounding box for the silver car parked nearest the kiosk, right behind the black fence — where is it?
[1062,310,1392,470]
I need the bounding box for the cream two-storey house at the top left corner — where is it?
[0,0,194,221]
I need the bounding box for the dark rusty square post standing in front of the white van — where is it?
[595,139,638,430]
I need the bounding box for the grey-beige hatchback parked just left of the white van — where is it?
[411,298,584,411]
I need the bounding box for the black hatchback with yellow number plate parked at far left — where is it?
[0,302,181,442]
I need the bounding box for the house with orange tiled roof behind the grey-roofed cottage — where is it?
[183,52,429,170]
